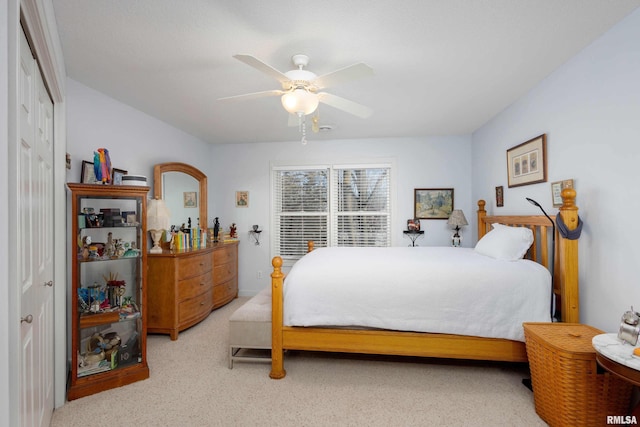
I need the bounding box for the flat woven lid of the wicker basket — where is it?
[522,322,604,355]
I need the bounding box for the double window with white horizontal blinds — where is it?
[272,164,391,260]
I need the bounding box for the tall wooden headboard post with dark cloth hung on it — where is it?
[558,188,580,323]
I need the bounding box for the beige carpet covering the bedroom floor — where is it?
[51,298,546,427]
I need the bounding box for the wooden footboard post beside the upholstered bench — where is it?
[269,256,287,380]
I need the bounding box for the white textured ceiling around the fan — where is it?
[53,0,640,143]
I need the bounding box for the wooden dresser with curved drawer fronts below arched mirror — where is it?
[147,242,238,340]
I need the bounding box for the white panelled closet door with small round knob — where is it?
[14,27,54,426]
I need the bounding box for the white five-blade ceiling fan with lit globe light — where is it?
[219,54,373,118]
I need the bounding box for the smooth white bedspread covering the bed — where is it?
[284,247,551,341]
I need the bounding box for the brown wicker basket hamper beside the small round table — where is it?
[523,323,632,427]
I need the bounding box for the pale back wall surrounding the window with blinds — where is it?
[209,136,477,295]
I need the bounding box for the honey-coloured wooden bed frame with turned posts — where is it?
[269,189,579,379]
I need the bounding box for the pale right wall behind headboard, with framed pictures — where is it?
[472,9,640,332]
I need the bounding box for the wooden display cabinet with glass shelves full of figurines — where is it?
[67,183,149,400]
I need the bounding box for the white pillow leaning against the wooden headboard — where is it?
[475,224,533,261]
